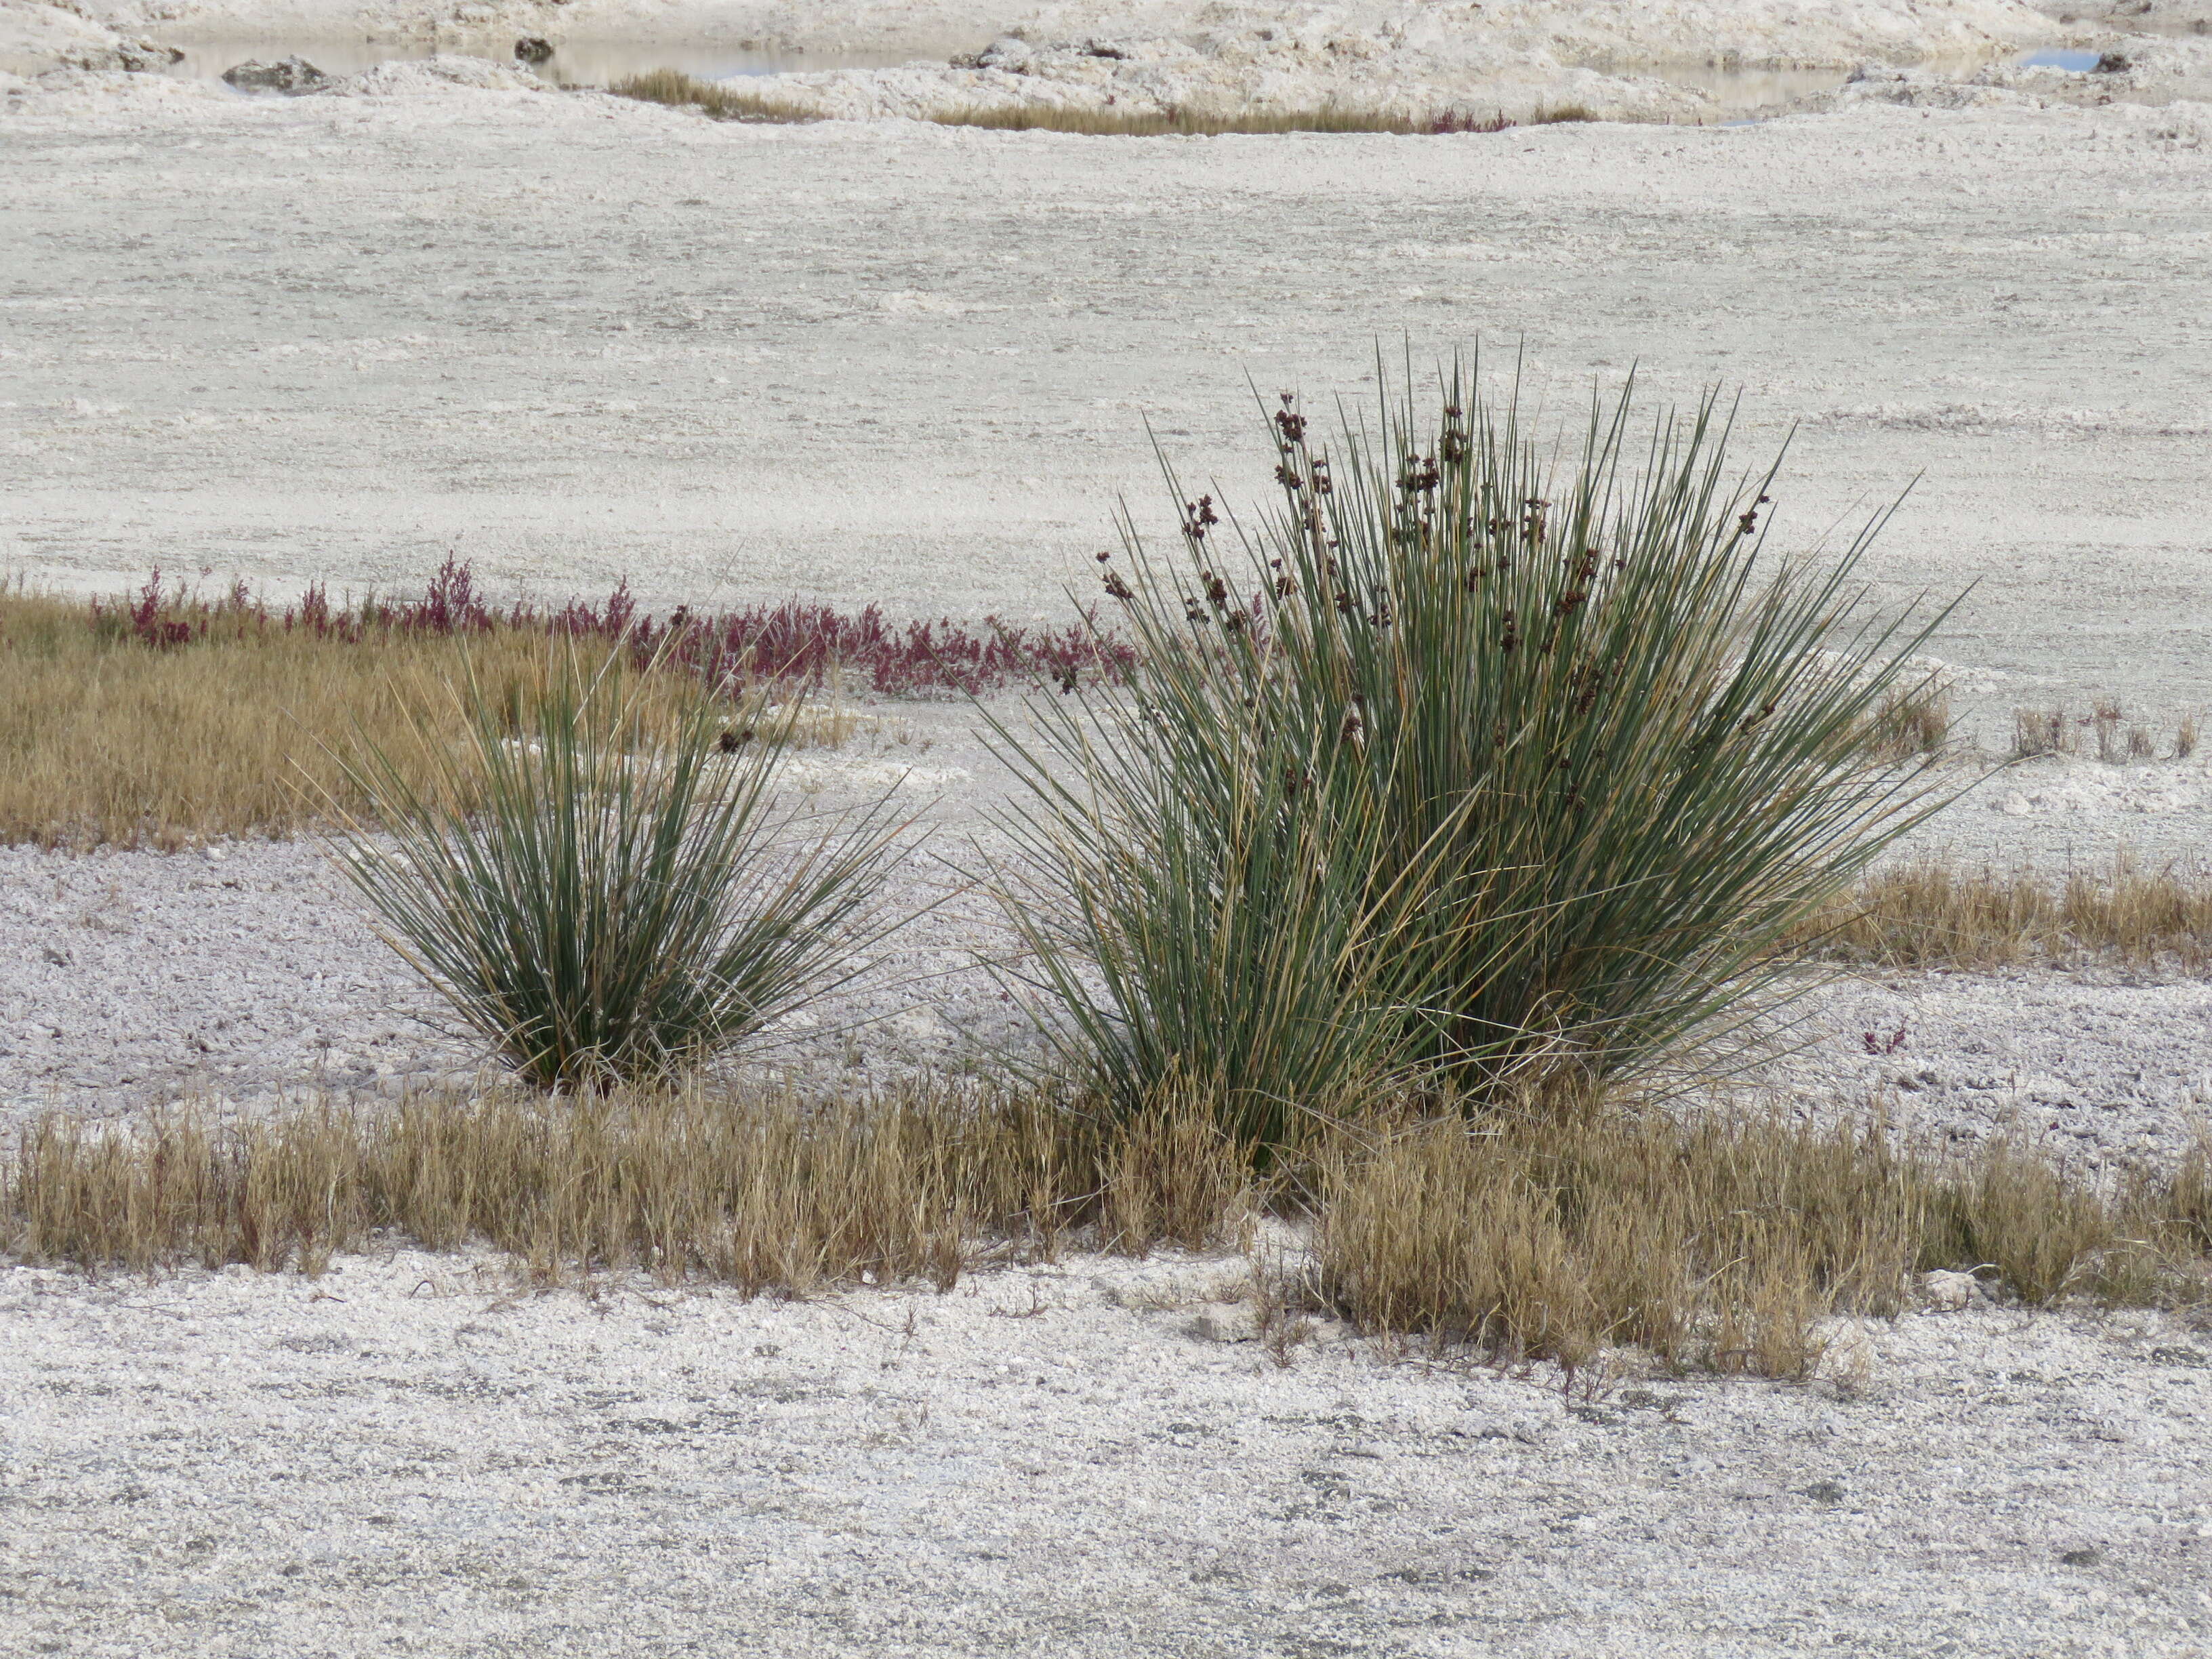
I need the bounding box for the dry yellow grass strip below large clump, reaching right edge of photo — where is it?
[1312,1113,2212,1376]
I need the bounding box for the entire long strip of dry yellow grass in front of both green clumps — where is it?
[13,1090,2212,1376]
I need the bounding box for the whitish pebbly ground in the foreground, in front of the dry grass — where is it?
[0,1252,2212,1659]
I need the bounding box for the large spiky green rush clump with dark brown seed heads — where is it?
[1000,365,1940,1141]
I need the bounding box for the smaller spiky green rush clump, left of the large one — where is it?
[334,644,898,1088]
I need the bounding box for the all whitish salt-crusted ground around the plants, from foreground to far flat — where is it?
[0,29,2212,1659]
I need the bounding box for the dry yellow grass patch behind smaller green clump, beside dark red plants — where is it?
[0,593,852,847]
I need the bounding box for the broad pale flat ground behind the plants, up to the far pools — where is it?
[0,77,2212,714]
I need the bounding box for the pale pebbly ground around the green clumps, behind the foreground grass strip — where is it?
[0,703,2212,1162]
